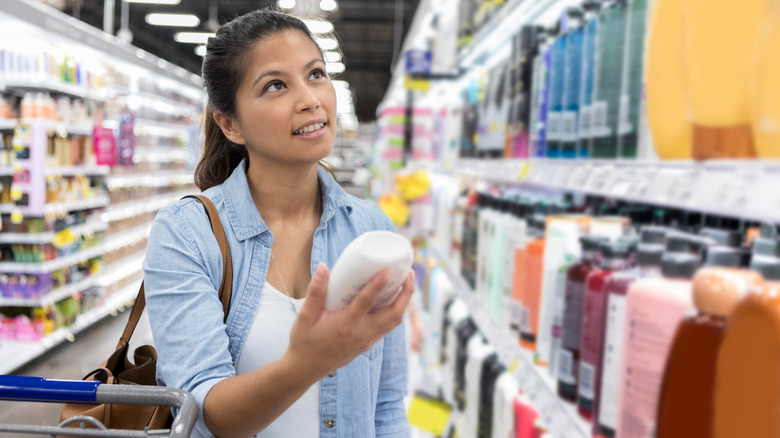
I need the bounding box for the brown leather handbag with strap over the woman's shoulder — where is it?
[60,195,233,430]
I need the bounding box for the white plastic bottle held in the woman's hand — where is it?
[325,231,413,312]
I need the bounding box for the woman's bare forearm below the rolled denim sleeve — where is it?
[203,354,322,438]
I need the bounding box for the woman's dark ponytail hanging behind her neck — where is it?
[195,105,249,191]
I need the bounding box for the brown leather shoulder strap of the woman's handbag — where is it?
[116,195,233,349]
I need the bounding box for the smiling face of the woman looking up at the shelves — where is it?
[218,30,336,164]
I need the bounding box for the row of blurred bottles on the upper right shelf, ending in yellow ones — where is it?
[402,0,780,163]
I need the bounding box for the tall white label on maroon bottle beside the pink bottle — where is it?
[599,294,626,430]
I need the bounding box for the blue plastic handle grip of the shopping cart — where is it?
[0,375,100,403]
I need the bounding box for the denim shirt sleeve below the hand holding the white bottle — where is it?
[374,324,410,438]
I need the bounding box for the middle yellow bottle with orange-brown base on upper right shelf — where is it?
[680,0,772,159]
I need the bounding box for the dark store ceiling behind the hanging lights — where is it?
[63,0,419,121]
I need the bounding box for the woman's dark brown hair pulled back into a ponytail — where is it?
[195,10,333,190]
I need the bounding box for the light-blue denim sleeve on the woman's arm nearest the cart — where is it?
[143,206,235,436]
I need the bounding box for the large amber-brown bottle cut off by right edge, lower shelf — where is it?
[711,282,780,438]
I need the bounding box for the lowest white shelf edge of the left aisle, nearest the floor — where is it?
[0,281,141,374]
